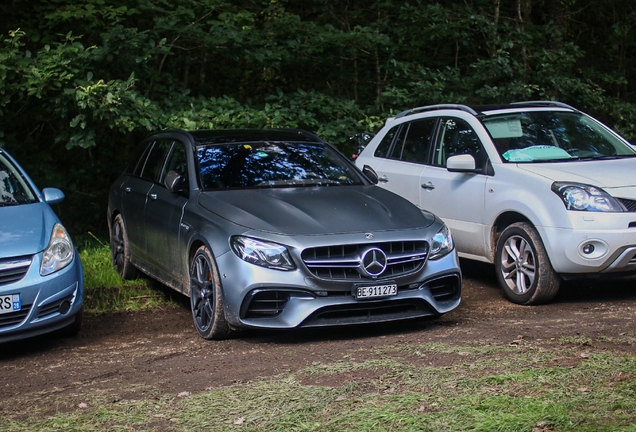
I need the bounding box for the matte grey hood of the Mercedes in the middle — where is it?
[199,186,434,235]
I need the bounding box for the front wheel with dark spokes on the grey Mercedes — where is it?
[190,246,231,339]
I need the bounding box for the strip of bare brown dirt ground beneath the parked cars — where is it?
[0,262,636,418]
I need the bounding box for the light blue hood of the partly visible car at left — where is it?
[0,203,57,258]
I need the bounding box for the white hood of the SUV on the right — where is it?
[517,158,636,188]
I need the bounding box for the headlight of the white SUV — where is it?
[552,182,625,212]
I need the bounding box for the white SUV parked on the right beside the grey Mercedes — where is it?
[356,101,636,304]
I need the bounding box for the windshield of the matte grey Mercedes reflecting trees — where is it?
[197,142,363,190]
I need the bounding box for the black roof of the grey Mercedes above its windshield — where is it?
[189,129,324,144]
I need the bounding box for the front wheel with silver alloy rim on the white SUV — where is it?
[495,222,561,305]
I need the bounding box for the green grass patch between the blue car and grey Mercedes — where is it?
[78,233,180,314]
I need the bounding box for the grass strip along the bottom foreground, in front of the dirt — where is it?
[7,344,636,432]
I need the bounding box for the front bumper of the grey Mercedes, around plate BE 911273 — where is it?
[217,246,461,329]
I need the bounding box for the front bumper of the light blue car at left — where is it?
[0,251,84,343]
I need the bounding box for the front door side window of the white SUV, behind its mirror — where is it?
[433,118,486,167]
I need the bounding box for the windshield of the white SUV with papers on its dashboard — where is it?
[483,110,636,163]
